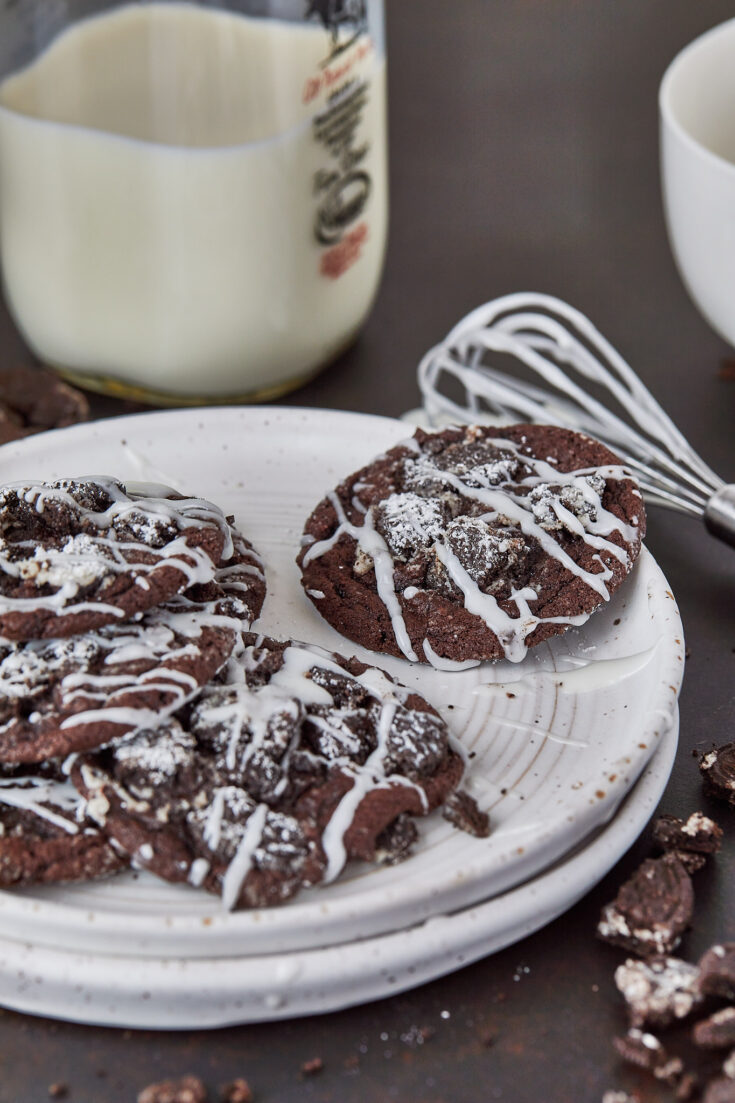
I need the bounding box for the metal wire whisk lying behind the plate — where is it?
[418,292,735,546]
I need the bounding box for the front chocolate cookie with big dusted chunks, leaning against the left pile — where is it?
[73,634,462,908]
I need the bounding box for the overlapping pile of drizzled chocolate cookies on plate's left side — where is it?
[0,479,470,908]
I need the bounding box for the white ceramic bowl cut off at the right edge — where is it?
[659,19,735,345]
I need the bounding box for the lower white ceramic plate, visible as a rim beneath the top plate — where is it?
[0,713,679,1030]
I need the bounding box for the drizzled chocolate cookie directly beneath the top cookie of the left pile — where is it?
[0,529,265,762]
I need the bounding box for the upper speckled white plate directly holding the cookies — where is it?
[0,408,683,959]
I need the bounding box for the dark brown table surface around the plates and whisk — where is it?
[0,0,735,1103]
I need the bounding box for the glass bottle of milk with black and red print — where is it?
[0,0,387,404]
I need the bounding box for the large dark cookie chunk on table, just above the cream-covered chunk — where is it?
[597,854,694,957]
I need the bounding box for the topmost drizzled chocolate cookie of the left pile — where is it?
[0,478,233,640]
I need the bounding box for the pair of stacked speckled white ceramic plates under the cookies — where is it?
[0,408,683,1029]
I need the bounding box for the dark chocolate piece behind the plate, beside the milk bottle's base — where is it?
[0,364,89,445]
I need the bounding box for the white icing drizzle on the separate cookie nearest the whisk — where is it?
[303,428,639,670]
